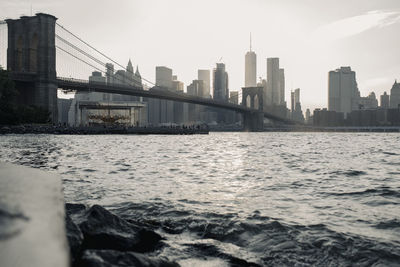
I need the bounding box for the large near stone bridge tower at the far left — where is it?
[6,13,57,122]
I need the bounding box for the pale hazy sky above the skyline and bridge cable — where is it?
[0,0,400,111]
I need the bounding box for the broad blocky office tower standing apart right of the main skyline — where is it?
[328,67,360,117]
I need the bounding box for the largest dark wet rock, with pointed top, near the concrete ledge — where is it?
[79,205,162,252]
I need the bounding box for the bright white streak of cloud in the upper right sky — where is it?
[312,10,400,41]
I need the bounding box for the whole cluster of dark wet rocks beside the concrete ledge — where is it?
[65,203,180,267]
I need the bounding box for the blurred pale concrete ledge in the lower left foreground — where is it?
[0,163,69,267]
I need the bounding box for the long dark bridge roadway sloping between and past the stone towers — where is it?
[57,77,296,124]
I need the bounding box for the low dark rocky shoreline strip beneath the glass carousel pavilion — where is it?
[0,125,209,135]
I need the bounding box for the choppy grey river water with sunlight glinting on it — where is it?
[0,133,400,266]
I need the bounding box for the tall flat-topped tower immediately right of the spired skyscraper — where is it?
[266,58,281,105]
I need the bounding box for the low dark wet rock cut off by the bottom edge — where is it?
[79,250,179,267]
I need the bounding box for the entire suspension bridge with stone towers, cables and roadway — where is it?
[0,13,297,131]
